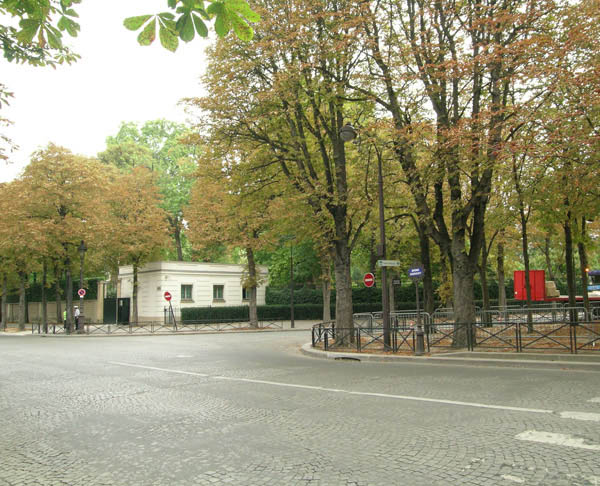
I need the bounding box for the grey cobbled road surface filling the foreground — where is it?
[0,332,600,486]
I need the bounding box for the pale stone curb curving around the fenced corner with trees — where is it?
[300,343,600,372]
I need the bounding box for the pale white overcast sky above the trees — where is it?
[0,0,209,182]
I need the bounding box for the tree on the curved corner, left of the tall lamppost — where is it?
[190,0,371,342]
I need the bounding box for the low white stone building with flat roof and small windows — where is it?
[118,262,268,321]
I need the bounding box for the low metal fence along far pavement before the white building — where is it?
[31,319,283,335]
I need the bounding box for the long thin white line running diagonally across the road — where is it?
[109,361,553,413]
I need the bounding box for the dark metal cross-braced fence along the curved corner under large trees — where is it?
[312,321,600,353]
